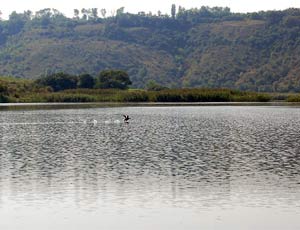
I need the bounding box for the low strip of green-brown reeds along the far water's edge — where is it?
[4,89,272,103]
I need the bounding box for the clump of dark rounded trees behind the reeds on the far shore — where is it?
[35,70,132,92]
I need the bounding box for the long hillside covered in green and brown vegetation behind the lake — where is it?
[0,5,300,92]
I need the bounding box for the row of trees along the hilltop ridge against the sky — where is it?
[0,4,299,35]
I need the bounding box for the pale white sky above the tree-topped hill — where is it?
[0,0,300,18]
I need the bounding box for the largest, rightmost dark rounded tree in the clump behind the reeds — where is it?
[98,70,132,89]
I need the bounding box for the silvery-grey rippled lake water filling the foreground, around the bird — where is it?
[0,106,300,230]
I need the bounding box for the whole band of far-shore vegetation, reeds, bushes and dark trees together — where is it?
[0,70,300,103]
